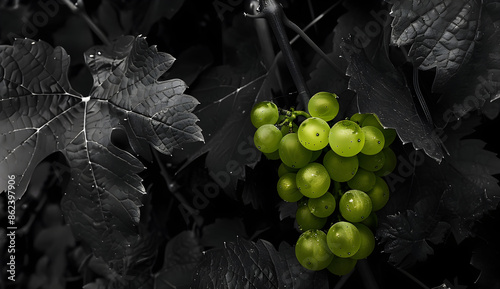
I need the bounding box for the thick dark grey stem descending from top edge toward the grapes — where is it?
[245,0,310,107]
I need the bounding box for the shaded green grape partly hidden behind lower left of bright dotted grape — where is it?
[279,133,312,168]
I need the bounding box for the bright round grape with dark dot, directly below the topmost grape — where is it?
[298,117,330,151]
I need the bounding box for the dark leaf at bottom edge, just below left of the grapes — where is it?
[191,238,328,289]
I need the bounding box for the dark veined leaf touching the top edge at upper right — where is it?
[388,0,482,88]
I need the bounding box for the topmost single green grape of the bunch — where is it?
[307,92,339,121]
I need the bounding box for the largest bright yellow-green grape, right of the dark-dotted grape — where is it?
[329,120,365,157]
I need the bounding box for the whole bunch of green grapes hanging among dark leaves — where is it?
[250,92,397,275]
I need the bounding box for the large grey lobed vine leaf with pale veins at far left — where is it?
[0,36,203,274]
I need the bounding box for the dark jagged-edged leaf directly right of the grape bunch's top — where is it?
[343,40,443,161]
